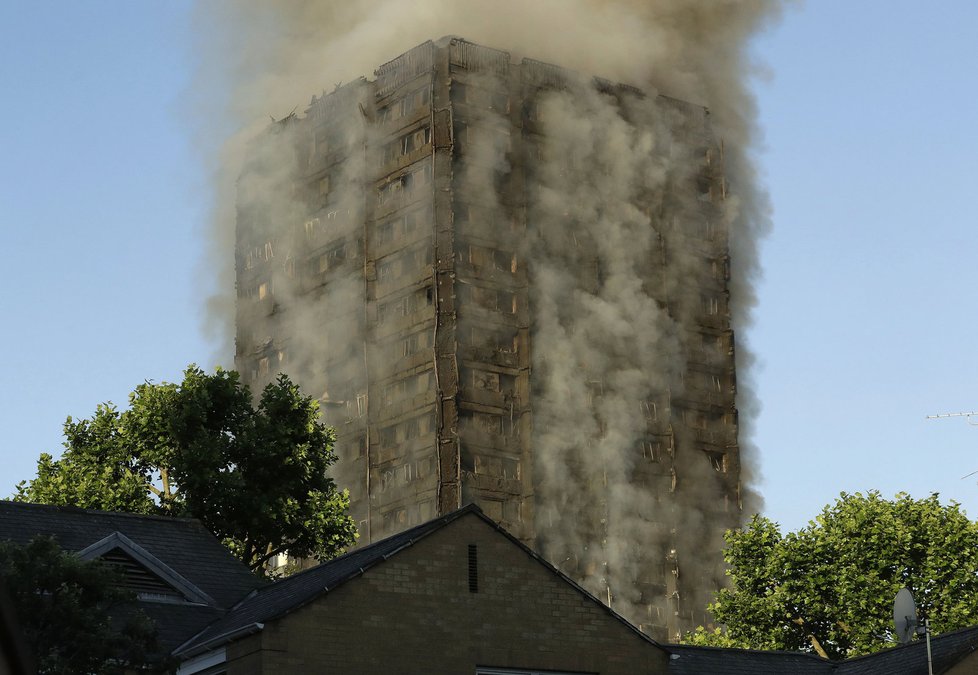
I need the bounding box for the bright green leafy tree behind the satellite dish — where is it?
[685,491,978,659]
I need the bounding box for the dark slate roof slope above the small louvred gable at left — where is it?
[0,501,262,608]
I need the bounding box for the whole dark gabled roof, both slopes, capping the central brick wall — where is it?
[174,504,658,658]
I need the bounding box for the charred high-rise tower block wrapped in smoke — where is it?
[236,38,740,638]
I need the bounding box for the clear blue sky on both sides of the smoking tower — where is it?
[0,0,978,529]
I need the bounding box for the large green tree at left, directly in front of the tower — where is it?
[14,366,357,569]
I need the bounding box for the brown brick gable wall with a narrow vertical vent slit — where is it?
[228,515,668,675]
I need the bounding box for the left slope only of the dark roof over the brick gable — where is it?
[177,505,482,655]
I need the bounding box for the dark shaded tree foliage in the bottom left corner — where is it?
[0,537,156,673]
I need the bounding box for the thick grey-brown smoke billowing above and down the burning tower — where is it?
[198,0,779,636]
